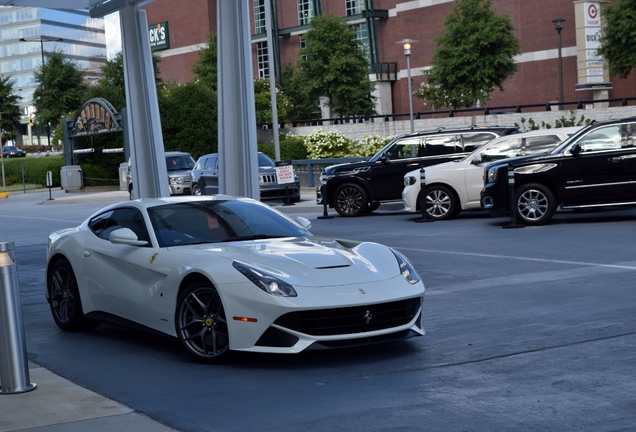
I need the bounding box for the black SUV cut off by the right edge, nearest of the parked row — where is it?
[481,117,636,225]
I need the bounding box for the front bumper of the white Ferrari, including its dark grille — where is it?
[222,276,424,354]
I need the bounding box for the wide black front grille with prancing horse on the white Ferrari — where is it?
[274,297,420,336]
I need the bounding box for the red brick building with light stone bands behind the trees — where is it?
[145,0,636,120]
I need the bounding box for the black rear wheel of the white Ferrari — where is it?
[47,259,94,331]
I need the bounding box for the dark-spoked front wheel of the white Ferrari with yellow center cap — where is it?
[175,281,230,363]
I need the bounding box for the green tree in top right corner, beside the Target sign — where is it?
[598,0,636,78]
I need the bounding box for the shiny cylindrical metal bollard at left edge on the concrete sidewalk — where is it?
[0,242,37,394]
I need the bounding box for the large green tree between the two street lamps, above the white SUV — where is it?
[415,0,520,108]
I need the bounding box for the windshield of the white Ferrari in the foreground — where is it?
[148,200,311,247]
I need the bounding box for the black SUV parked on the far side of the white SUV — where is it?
[316,126,518,216]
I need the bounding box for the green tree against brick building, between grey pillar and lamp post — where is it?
[296,15,375,116]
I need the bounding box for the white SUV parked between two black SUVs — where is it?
[402,127,581,220]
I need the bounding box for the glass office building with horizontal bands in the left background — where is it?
[0,6,106,145]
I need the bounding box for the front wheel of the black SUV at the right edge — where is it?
[515,183,556,225]
